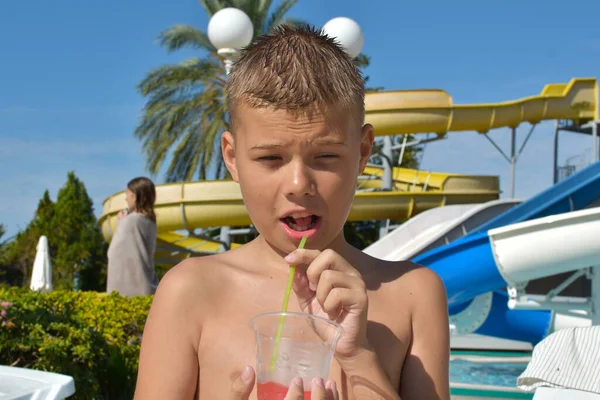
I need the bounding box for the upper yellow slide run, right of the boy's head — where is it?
[365,78,600,135]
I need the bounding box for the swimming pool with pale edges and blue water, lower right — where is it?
[450,352,533,400]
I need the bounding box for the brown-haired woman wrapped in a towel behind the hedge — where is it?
[106,177,158,296]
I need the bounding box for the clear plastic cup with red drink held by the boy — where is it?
[250,312,343,400]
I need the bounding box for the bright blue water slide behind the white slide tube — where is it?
[413,162,600,343]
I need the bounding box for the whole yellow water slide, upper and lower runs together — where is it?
[99,78,598,263]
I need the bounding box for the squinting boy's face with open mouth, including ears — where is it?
[221,105,374,252]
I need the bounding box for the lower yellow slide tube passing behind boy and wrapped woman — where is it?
[99,167,499,264]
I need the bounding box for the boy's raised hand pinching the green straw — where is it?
[285,249,369,358]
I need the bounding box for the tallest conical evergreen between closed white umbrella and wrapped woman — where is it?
[49,171,106,290]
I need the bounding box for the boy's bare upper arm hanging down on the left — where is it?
[134,262,201,400]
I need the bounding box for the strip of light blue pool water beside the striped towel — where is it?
[450,360,527,388]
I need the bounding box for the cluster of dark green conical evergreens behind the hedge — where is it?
[0,172,107,290]
